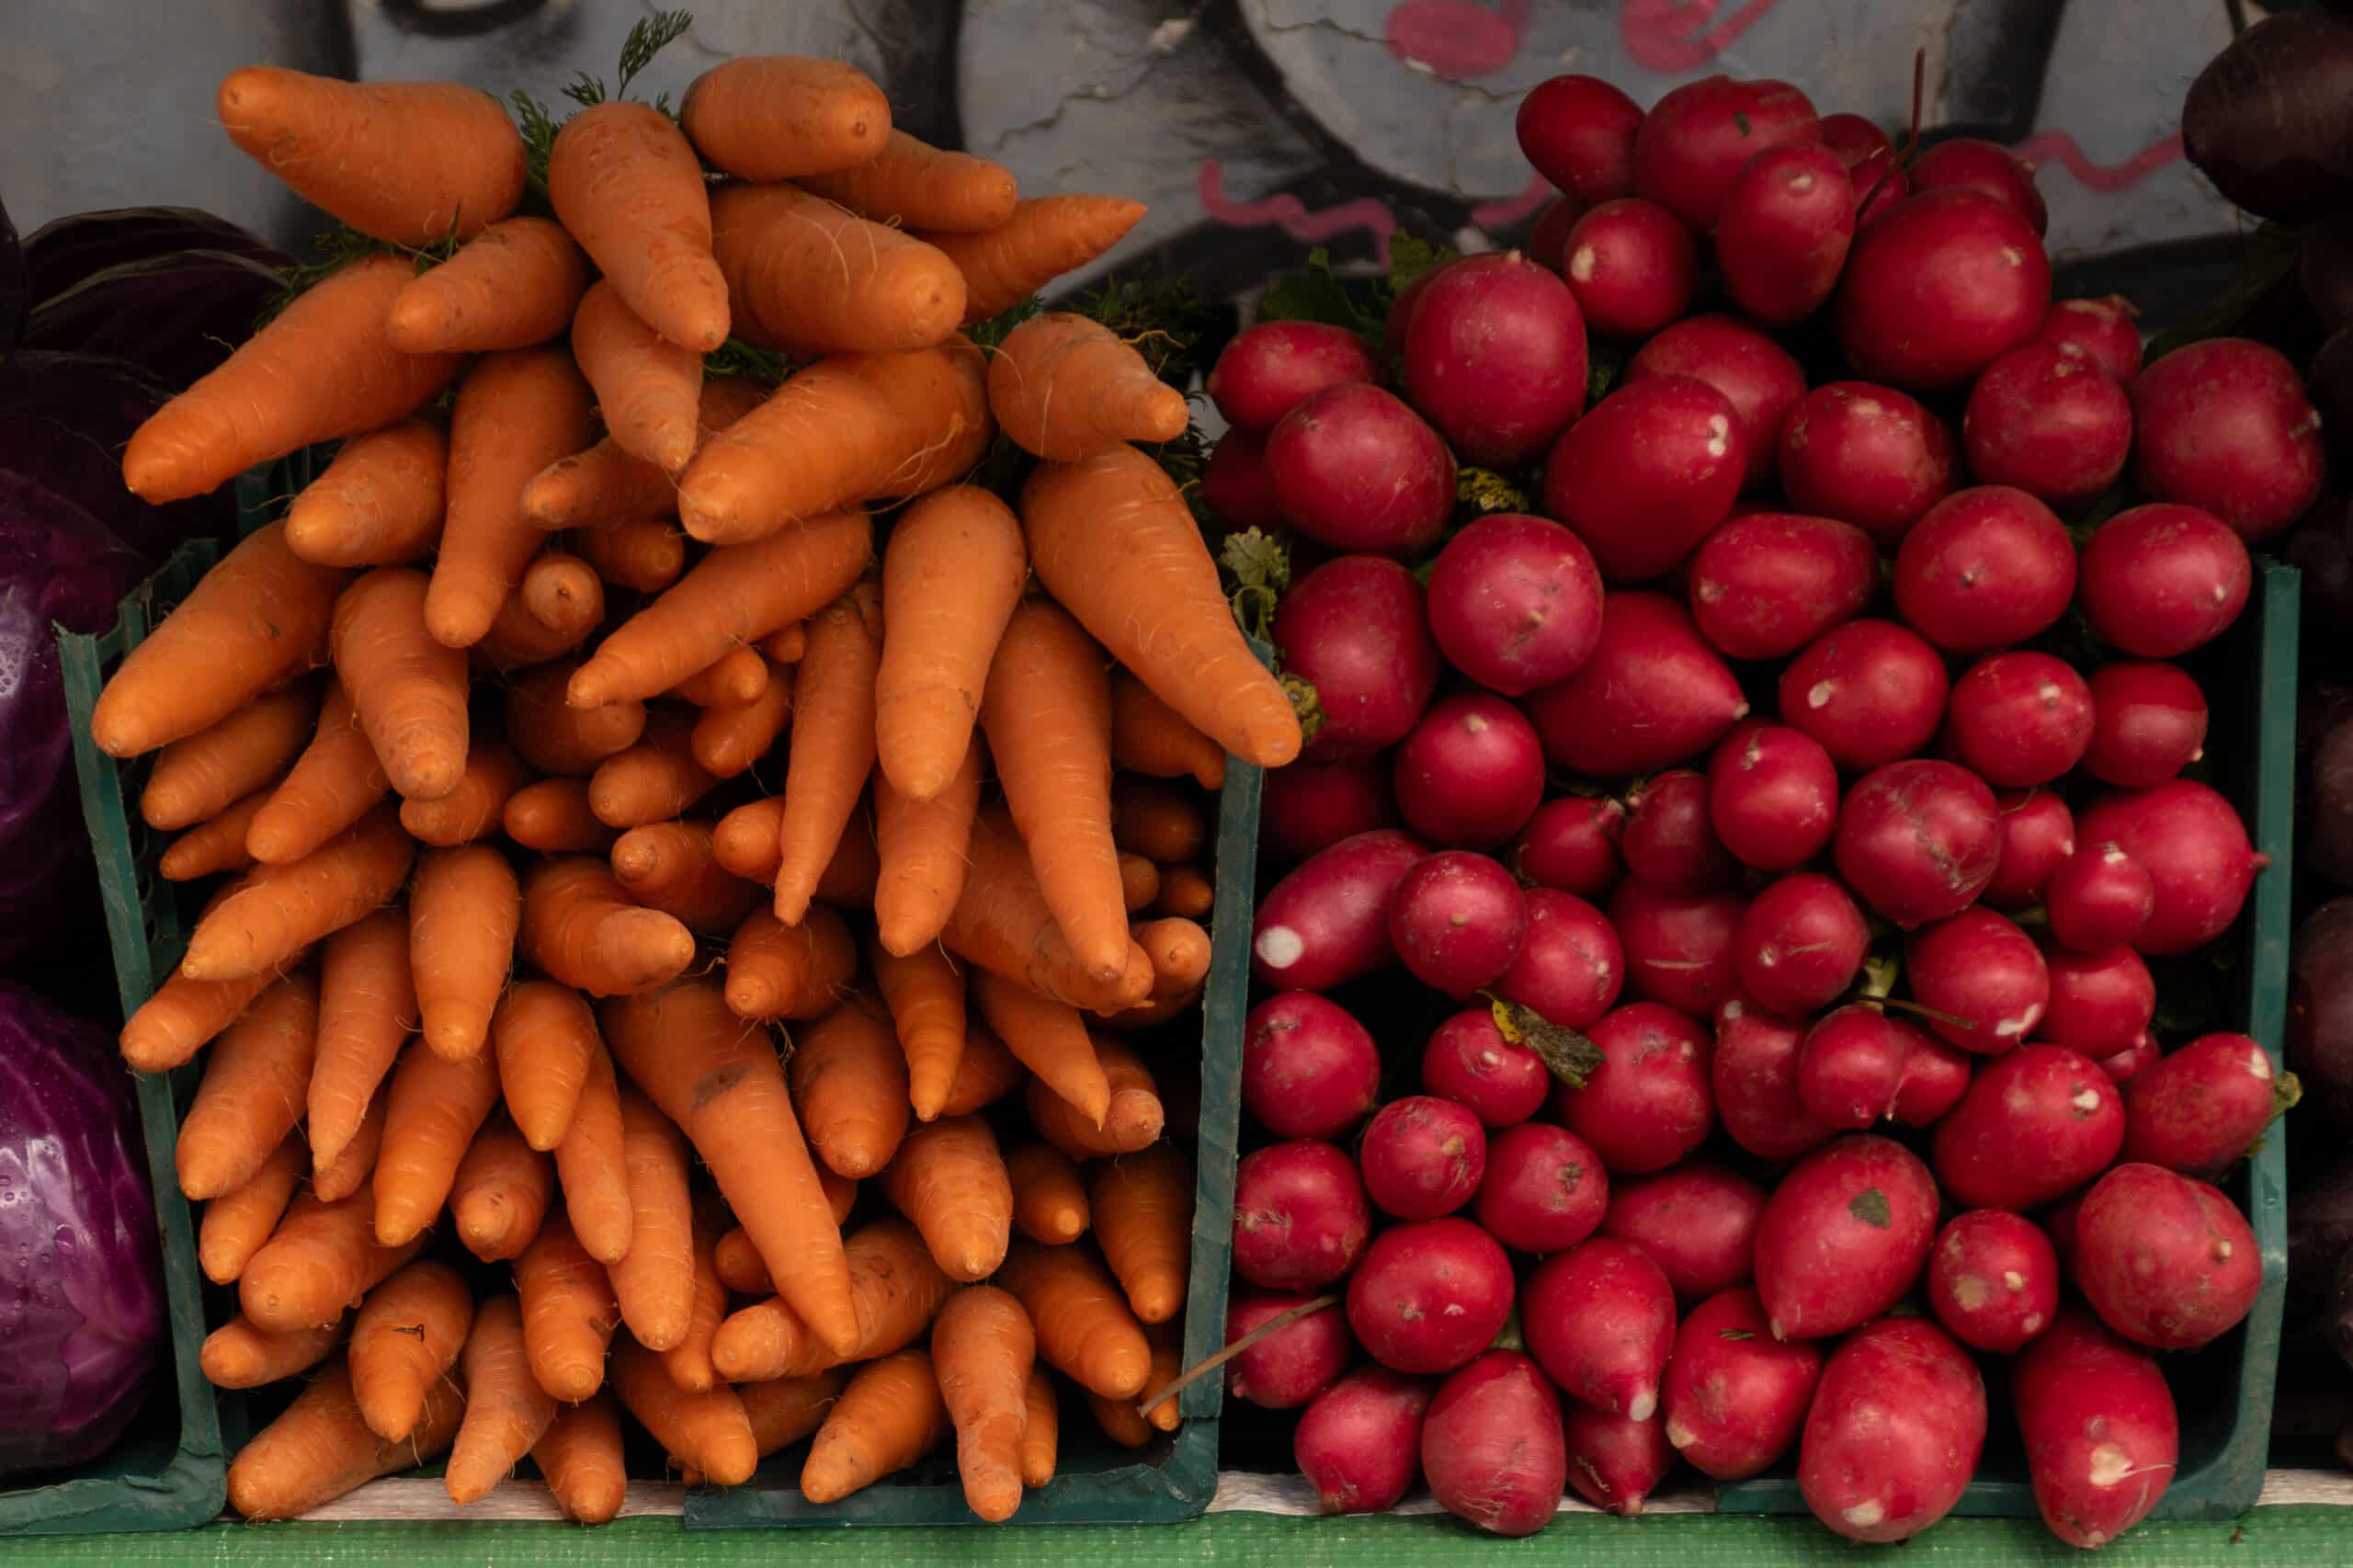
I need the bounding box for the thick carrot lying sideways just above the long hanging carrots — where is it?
[677,336,995,543]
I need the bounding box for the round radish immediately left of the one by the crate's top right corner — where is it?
[1894,485,2075,654]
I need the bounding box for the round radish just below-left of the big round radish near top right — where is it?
[1777,381,1960,546]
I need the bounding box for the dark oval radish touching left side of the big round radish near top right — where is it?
[1715,142,1854,327]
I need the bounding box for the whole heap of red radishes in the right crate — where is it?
[1205,63,2323,1547]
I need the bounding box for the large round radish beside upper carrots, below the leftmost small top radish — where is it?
[1266,383,1449,556]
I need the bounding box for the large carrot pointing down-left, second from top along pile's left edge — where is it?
[118,256,459,501]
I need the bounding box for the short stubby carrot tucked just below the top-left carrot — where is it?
[383,217,588,353]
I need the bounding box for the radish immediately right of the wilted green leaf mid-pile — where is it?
[1553,1003,1713,1177]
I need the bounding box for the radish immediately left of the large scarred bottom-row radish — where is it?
[1659,1290,1821,1481]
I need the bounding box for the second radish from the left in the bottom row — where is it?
[1421,1351,1570,1535]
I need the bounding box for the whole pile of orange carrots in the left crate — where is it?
[92,27,1299,1521]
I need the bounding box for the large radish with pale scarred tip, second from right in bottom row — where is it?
[1798,1318,1986,1542]
